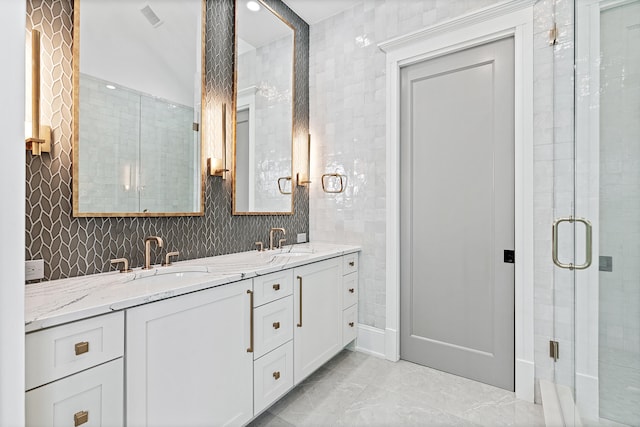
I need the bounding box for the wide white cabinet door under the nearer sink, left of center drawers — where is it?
[126,280,253,427]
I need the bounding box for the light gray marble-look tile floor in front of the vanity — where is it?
[250,350,544,427]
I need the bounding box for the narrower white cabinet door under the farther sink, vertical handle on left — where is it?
[293,258,342,384]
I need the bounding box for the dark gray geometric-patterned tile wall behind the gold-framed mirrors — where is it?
[25,0,309,280]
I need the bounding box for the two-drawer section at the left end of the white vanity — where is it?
[25,312,124,427]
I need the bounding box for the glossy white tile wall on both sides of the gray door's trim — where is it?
[309,0,573,400]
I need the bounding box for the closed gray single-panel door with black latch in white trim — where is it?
[400,38,515,390]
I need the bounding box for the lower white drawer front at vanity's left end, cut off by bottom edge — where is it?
[25,359,124,427]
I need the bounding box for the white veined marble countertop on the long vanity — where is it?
[25,242,360,332]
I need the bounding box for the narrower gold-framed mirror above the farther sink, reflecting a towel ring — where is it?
[233,0,295,215]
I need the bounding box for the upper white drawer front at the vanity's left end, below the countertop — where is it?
[25,312,124,390]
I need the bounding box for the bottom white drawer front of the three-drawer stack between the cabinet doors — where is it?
[253,341,293,415]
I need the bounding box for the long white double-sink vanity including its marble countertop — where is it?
[26,243,359,426]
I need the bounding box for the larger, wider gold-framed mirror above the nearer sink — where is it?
[73,0,205,216]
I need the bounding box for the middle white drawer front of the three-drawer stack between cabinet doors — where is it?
[253,295,293,359]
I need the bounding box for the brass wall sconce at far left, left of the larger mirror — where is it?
[25,30,51,156]
